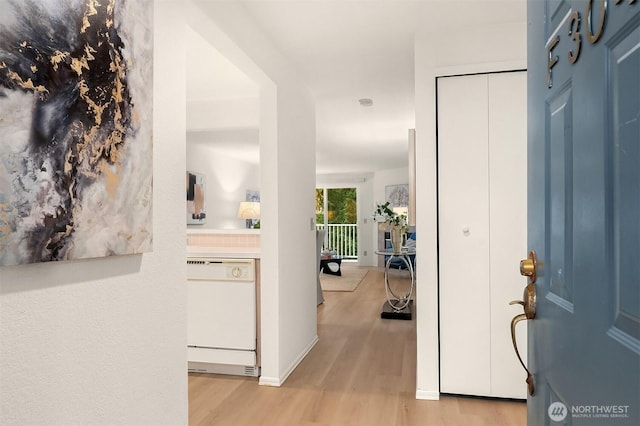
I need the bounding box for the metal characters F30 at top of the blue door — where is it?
[547,0,636,88]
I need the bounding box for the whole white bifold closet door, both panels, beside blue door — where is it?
[438,72,528,398]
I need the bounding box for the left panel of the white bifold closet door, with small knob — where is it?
[438,75,491,395]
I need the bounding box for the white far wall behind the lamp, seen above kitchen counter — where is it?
[185,142,260,229]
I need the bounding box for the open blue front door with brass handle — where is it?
[523,0,640,425]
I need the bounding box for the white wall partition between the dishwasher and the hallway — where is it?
[188,1,317,386]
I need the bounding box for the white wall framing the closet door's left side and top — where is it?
[415,22,527,399]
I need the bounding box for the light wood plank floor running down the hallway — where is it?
[189,269,526,426]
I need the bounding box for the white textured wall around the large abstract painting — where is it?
[0,2,187,425]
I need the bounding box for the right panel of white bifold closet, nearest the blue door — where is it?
[489,72,527,399]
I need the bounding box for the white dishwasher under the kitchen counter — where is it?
[187,257,259,377]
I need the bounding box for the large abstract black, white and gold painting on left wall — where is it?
[0,0,153,265]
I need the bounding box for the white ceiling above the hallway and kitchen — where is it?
[187,0,526,175]
